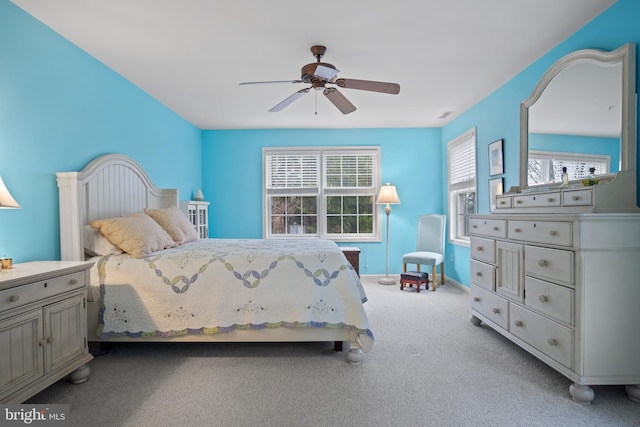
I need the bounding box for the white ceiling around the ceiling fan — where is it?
[13,0,615,129]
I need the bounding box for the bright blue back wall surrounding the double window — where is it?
[202,129,444,274]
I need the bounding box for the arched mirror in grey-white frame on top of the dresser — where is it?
[520,43,636,190]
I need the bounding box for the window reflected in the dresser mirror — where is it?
[527,151,611,185]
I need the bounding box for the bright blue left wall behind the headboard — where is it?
[0,0,202,262]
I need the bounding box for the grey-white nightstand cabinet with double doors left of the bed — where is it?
[0,261,93,403]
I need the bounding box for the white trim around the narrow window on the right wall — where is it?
[447,127,478,247]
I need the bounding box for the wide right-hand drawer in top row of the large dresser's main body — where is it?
[508,220,573,246]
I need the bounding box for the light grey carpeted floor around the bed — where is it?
[29,277,640,427]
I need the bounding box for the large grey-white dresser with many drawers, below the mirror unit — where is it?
[469,207,640,403]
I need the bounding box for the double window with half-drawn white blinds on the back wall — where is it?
[263,147,380,241]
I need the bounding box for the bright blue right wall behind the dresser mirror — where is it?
[442,0,640,286]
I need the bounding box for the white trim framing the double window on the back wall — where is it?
[262,146,382,242]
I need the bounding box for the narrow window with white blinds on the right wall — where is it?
[447,128,476,246]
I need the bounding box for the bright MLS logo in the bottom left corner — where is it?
[0,405,71,427]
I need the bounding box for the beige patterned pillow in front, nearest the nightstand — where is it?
[90,212,176,258]
